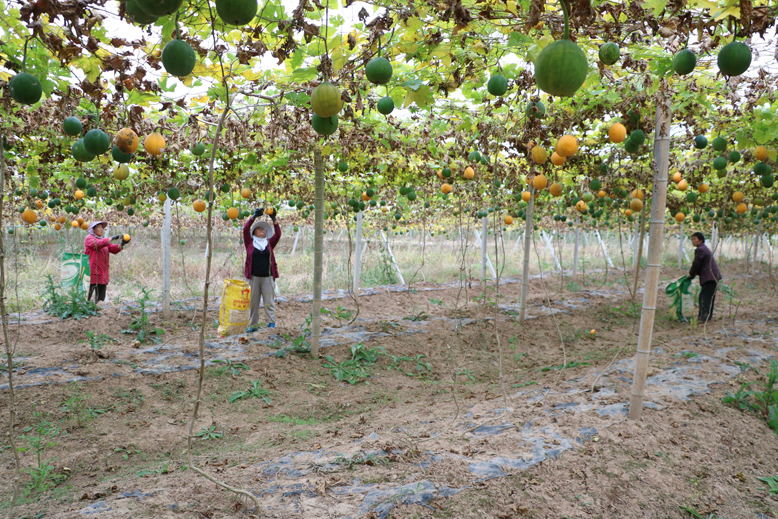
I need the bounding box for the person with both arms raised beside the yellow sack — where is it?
[243,209,281,333]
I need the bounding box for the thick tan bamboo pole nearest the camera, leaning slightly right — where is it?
[629,81,671,420]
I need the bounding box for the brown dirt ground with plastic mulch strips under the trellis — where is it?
[0,265,778,519]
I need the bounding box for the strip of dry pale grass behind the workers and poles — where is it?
[6,220,769,310]
